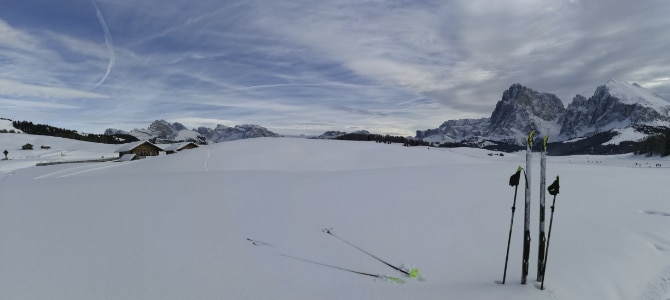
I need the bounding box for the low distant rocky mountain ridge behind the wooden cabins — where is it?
[105,120,279,144]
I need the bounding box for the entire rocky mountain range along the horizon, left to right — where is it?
[0,80,670,155]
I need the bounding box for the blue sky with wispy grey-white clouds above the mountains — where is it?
[0,0,670,135]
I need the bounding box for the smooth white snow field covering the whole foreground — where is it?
[0,134,670,300]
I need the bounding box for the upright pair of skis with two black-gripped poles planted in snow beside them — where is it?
[502,137,560,289]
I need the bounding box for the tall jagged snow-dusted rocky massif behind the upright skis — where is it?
[416,80,670,150]
